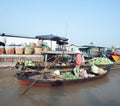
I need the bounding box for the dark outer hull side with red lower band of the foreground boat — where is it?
[16,71,108,87]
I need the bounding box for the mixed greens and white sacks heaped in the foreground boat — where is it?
[49,65,107,79]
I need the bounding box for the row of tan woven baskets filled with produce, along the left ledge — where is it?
[0,42,51,55]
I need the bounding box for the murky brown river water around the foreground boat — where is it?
[0,68,120,106]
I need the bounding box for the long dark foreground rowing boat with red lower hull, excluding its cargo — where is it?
[16,67,110,86]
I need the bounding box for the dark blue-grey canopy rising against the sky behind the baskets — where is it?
[36,34,68,41]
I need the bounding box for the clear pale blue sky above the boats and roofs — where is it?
[0,0,120,47]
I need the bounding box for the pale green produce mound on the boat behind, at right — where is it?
[88,57,113,65]
